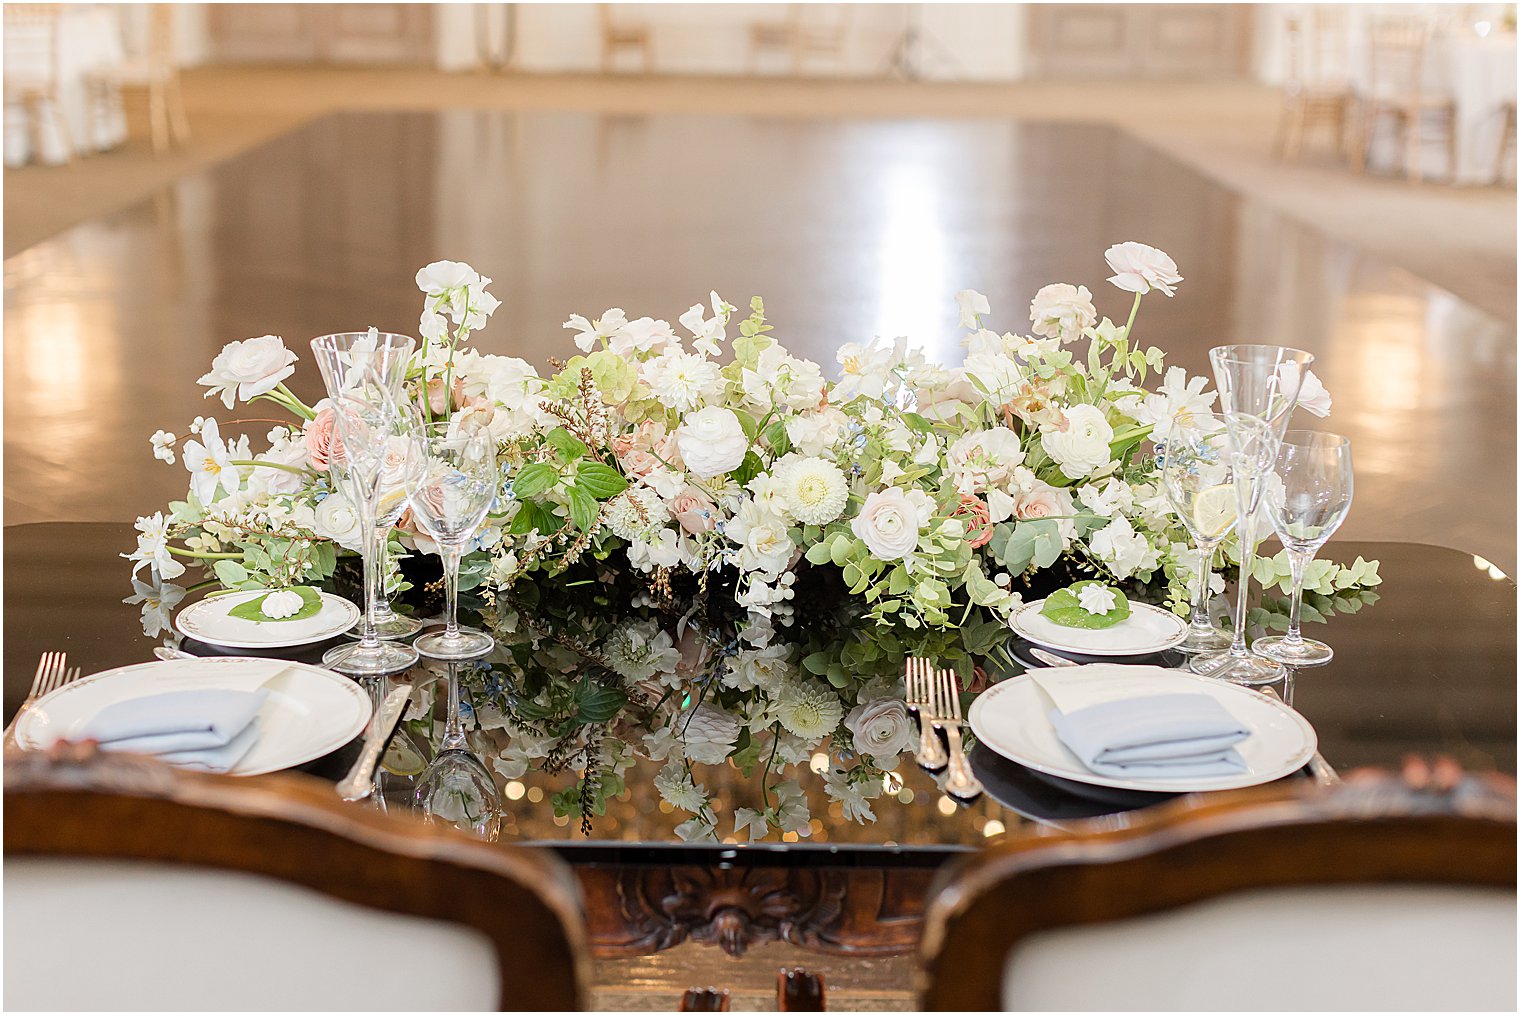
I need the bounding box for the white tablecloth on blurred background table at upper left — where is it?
[5,5,126,166]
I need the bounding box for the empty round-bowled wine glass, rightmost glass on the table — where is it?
[1251,430,1351,666]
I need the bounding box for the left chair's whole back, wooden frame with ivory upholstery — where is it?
[5,745,588,1010]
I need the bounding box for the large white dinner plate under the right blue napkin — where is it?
[967,662,1318,793]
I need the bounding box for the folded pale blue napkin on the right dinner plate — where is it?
[1050,694,1251,778]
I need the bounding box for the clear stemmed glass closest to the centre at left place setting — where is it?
[406,422,499,659]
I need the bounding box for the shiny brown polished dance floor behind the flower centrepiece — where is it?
[5,111,1515,571]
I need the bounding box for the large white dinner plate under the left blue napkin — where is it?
[15,656,372,775]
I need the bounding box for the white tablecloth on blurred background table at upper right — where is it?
[1351,32,1515,184]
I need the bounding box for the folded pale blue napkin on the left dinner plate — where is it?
[76,688,269,772]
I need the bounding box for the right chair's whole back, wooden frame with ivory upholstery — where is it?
[920,765,1515,1010]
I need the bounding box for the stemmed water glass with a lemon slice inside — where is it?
[1161,409,1236,655]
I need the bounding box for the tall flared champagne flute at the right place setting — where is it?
[1189,345,1315,684]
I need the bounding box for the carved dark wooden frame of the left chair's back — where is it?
[5,745,590,1010]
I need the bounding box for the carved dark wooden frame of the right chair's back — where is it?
[920,765,1515,1010]
